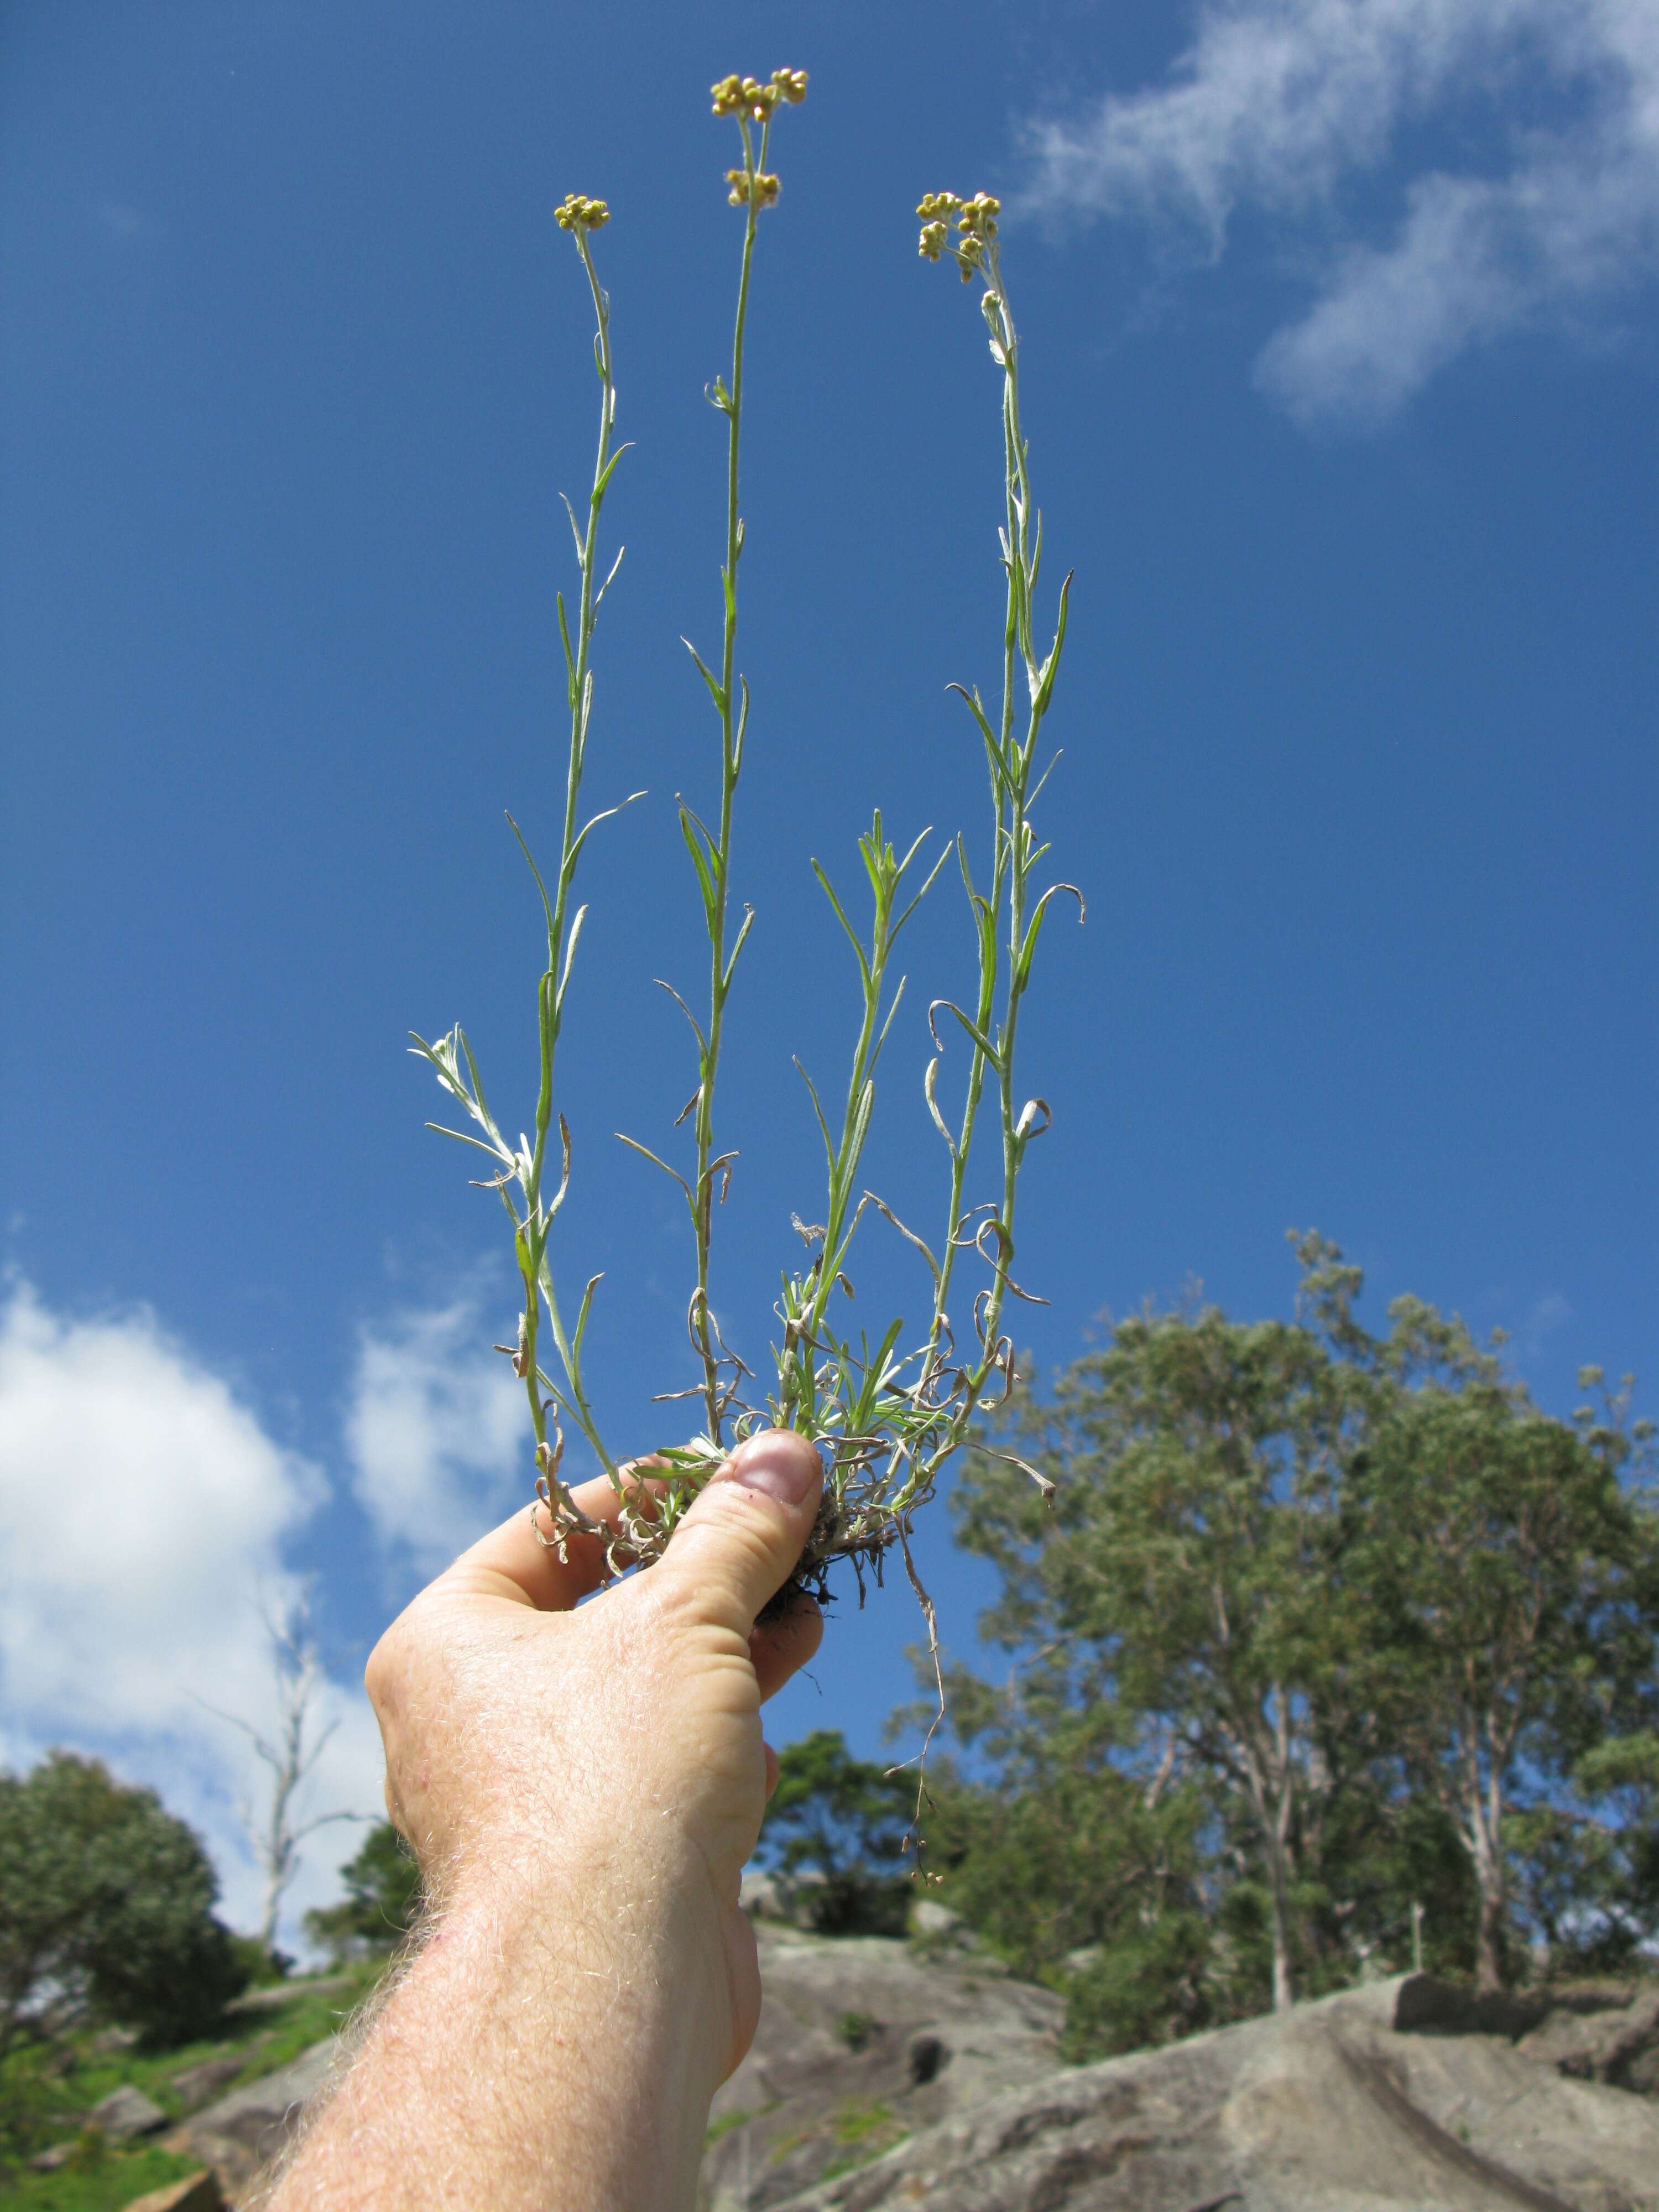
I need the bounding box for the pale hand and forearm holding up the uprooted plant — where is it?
[268,1431,823,2212]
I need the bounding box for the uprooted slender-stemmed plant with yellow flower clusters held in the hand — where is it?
[414,69,1082,1628]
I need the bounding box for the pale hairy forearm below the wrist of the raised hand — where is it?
[270,1854,730,2212]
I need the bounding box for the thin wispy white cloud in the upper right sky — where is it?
[1029,0,1659,425]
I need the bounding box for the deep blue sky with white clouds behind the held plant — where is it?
[0,0,1659,1913]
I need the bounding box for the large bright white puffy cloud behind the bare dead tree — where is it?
[0,1283,380,1942]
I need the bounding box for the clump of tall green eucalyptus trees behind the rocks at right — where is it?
[931,1234,1659,2033]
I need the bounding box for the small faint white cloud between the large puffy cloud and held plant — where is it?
[345,1298,529,1571]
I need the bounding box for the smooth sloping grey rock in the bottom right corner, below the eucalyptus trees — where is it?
[765,1975,1659,2212]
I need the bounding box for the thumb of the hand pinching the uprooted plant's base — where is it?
[650,1429,823,1637]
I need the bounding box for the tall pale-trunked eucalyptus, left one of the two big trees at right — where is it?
[958,1307,1376,2008]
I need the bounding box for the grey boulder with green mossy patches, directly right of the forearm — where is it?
[701,1924,1064,2212]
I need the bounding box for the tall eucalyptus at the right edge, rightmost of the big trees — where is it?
[1345,1345,1659,1989]
